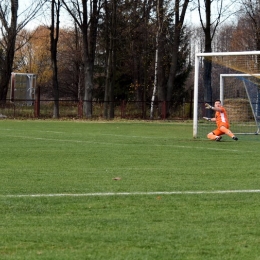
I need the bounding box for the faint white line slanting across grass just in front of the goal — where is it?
[5,135,248,153]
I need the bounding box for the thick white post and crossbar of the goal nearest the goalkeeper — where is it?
[193,51,260,138]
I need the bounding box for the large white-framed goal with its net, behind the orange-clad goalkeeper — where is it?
[193,51,260,138]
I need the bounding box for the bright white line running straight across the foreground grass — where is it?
[0,190,260,198]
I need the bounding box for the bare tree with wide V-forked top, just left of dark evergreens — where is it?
[62,0,102,118]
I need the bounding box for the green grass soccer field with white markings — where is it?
[0,120,260,260]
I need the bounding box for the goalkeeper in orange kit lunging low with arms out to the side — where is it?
[203,99,238,141]
